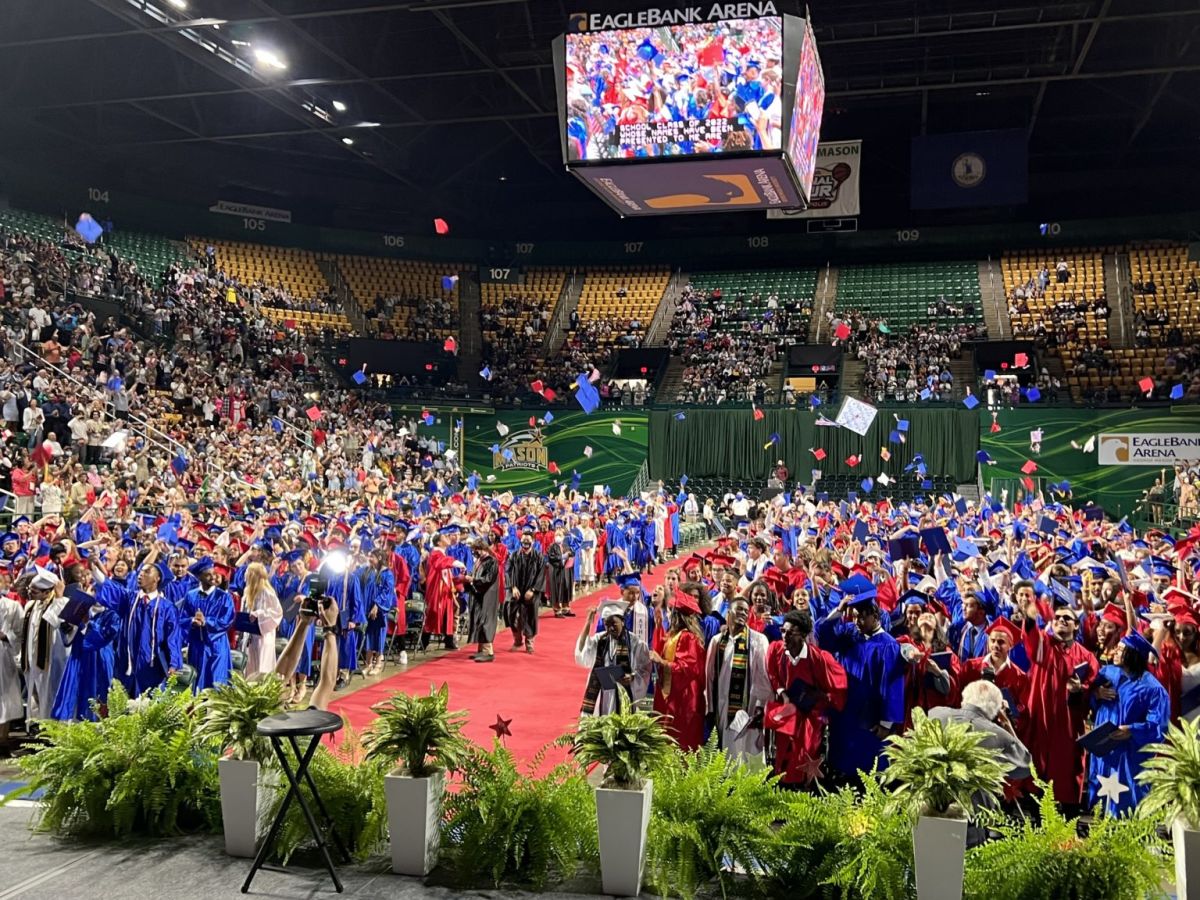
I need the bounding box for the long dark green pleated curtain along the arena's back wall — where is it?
[648,408,979,484]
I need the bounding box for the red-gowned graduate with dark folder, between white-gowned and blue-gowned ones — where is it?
[766,610,847,787]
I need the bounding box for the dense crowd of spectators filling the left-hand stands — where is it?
[0,220,455,515]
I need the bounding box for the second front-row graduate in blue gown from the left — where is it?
[115,565,182,697]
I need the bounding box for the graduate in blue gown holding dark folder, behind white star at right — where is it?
[1087,632,1171,816]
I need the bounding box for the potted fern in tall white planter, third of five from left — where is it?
[571,695,673,896]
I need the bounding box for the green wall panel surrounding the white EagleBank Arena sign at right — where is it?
[979,406,1200,517]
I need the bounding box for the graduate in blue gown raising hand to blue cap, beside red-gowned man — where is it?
[817,585,906,781]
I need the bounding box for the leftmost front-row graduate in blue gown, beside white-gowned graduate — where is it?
[50,563,121,721]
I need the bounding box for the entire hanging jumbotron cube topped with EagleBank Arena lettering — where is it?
[554,2,824,216]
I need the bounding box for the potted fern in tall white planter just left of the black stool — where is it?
[198,672,290,858]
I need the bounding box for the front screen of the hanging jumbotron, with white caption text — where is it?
[566,16,782,162]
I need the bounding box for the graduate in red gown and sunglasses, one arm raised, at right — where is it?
[1020,602,1099,806]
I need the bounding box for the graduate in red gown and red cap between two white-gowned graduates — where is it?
[650,590,707,751]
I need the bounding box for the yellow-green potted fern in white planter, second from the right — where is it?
[886,708,1008,900]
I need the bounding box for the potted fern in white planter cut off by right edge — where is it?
[1138,719,1200,900]
